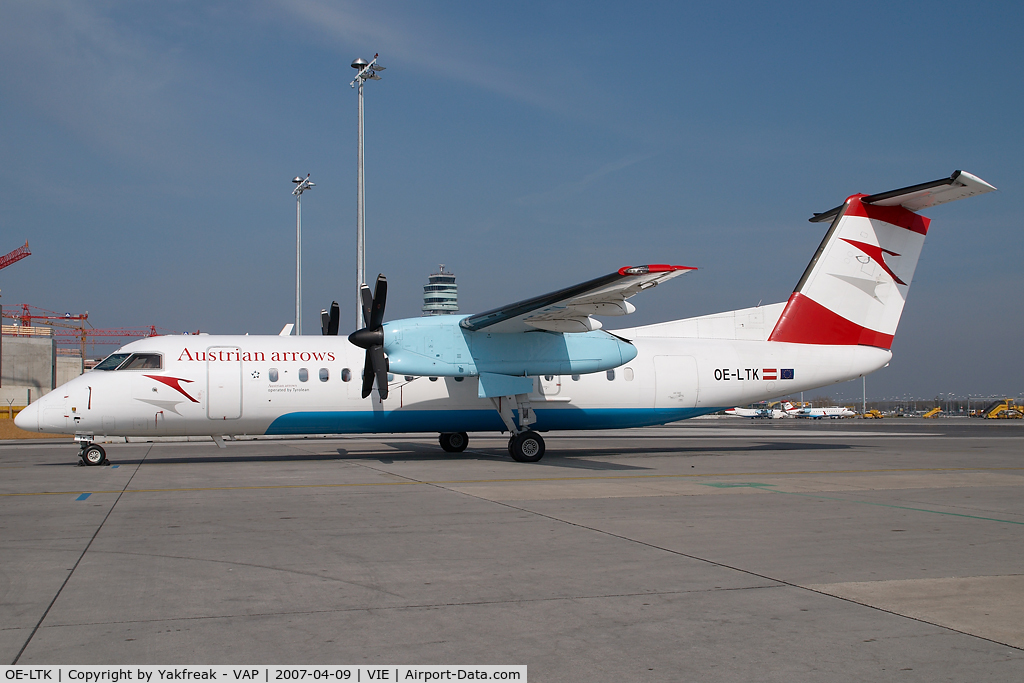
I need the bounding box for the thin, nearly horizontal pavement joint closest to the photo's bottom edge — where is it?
[0,584,782,632]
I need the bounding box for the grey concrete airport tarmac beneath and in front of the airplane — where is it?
[0,419,1024,682]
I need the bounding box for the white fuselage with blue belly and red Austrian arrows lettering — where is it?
[19,329,891,436]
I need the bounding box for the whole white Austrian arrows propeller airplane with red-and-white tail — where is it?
[15,171,995,465]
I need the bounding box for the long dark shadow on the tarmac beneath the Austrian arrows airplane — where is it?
[45,441,854,470]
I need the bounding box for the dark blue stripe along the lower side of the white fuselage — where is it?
[266,408,724,434]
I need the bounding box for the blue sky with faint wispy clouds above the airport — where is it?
[0,0,1024,396]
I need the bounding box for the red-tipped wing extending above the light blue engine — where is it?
[460,265,696,333]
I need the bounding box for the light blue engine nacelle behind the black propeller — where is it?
[384,315,637,377]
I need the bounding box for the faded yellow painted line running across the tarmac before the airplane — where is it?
[6,462,1024,498]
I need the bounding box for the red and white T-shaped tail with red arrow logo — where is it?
[768,171,995,349]
